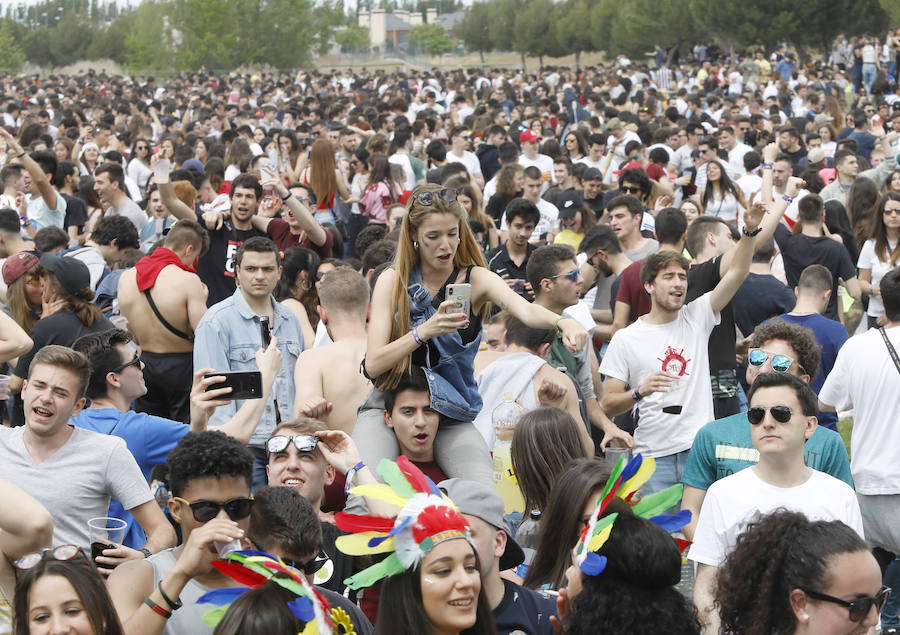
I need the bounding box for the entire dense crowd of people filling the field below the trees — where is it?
[0,29,900,635]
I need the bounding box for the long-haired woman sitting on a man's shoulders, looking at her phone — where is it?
[353,185,587,484]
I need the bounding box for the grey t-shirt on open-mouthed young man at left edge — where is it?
[0,427,153,547]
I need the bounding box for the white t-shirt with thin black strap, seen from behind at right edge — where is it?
[819,327,900,496]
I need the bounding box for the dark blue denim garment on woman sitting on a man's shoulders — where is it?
[407,269,481,421]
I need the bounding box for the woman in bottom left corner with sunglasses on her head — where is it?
[15,545,125,635]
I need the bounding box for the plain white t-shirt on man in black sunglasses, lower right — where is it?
[688,466,863,567]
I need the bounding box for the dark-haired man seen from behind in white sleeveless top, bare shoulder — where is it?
[474,317,594,456]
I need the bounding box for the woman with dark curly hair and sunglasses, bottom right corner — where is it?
[716,510,890,635]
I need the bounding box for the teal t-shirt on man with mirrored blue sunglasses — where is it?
[681,412,853,490]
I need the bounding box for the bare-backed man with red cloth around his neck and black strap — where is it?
[119,219,209,423]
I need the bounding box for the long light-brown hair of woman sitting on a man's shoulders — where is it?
[375,184,487,390]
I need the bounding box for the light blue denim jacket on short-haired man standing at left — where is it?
[194,289,303,447]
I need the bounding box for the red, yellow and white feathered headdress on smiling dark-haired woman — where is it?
[334,456,469,589]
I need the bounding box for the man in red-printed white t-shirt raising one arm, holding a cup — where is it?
[600,206,765,495]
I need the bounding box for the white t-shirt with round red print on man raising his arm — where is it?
[600,293,719,457]
